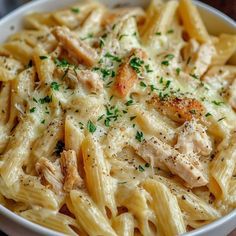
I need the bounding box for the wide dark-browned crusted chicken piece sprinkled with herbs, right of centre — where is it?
[148,96,204,123]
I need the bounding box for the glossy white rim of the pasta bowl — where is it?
[0,0,236,236]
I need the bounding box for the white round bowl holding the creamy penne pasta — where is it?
[0,0,236,236]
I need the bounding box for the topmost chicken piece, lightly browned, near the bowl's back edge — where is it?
[102,7,145,26]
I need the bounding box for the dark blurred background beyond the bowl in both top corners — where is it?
[0,0,236,20]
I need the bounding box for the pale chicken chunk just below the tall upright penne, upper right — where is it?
[183,39,215,77]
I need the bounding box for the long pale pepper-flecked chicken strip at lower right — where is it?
[137,137,208,188]
